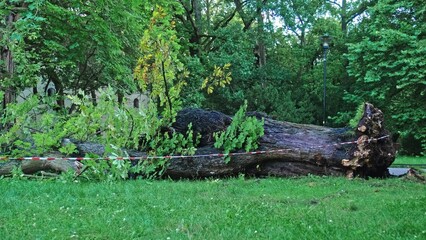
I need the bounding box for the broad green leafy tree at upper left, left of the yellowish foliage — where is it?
[2,0,147,109]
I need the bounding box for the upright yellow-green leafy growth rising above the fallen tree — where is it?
[135,6,187,124]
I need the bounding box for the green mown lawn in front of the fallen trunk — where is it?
[0,177,426,239]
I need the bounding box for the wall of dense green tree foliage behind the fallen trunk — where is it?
[0,0,426,154]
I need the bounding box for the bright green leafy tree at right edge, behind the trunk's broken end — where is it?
[345,0,426,154]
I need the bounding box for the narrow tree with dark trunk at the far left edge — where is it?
[0,0,43,109]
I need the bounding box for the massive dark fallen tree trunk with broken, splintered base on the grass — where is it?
[0,104,396,179]
